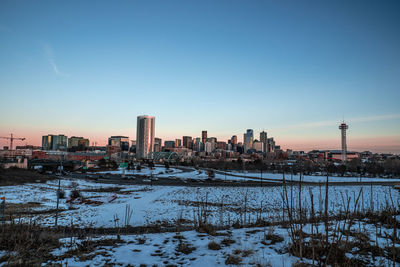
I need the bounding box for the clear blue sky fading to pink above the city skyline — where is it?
[0,0,400,153]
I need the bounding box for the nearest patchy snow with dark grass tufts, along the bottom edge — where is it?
[47,219,399,266]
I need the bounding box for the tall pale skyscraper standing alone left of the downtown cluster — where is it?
[136,115,155,159]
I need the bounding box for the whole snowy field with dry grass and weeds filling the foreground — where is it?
[0,169,400,266]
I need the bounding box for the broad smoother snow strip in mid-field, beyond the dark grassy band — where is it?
[0,179,399,227]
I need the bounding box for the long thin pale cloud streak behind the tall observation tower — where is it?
[276,114,400,129]
